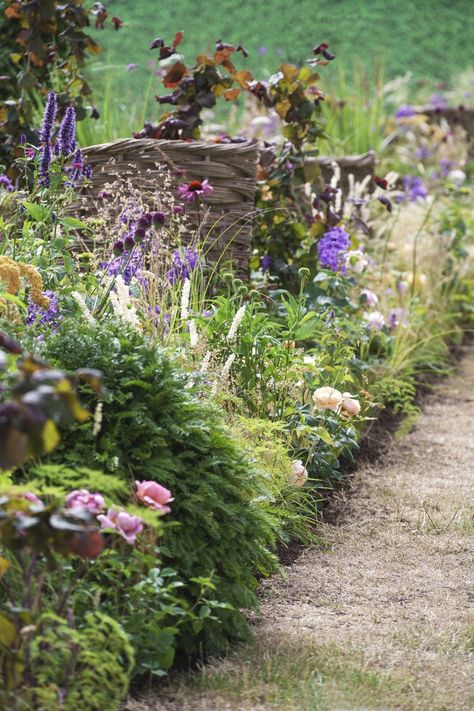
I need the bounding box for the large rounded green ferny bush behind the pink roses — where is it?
[38,322,278,651]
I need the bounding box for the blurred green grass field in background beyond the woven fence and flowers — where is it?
[84,0,474,142]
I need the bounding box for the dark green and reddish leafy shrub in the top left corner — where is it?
[0,0,120,169]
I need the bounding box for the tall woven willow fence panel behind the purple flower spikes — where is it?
[82,139,258,273]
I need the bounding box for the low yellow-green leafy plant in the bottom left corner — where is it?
[4,612,133,711]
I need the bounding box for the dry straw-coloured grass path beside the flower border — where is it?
[127,348,474,711]
